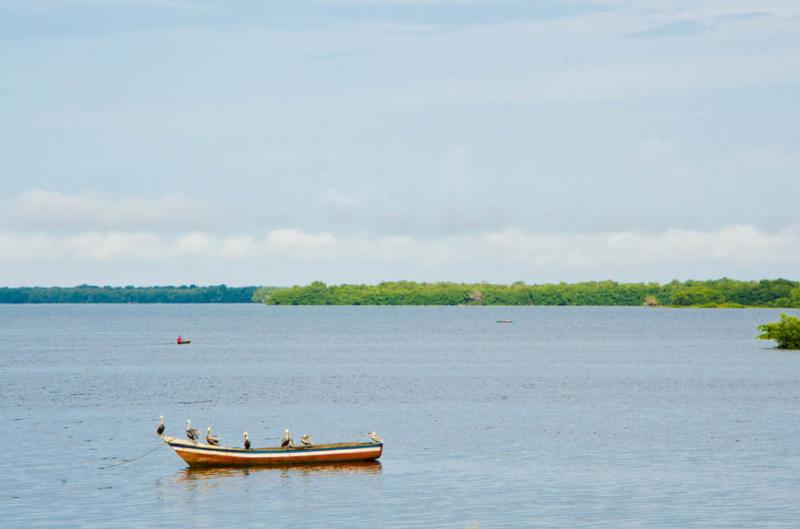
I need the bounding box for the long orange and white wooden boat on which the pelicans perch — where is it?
[162,435,383,468]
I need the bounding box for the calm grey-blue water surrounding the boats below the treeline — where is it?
[0,305,800,528]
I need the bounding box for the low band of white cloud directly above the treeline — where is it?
[0,225,800,284]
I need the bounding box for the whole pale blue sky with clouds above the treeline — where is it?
[0,0,800,286]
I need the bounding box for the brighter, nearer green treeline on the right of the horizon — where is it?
[254,279,800,308]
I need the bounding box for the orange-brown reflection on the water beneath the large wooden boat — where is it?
[176,461,381,483]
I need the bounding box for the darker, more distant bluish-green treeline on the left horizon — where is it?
[0,285,256,303]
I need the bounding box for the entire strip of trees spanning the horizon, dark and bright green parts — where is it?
[6,279,800,308]
